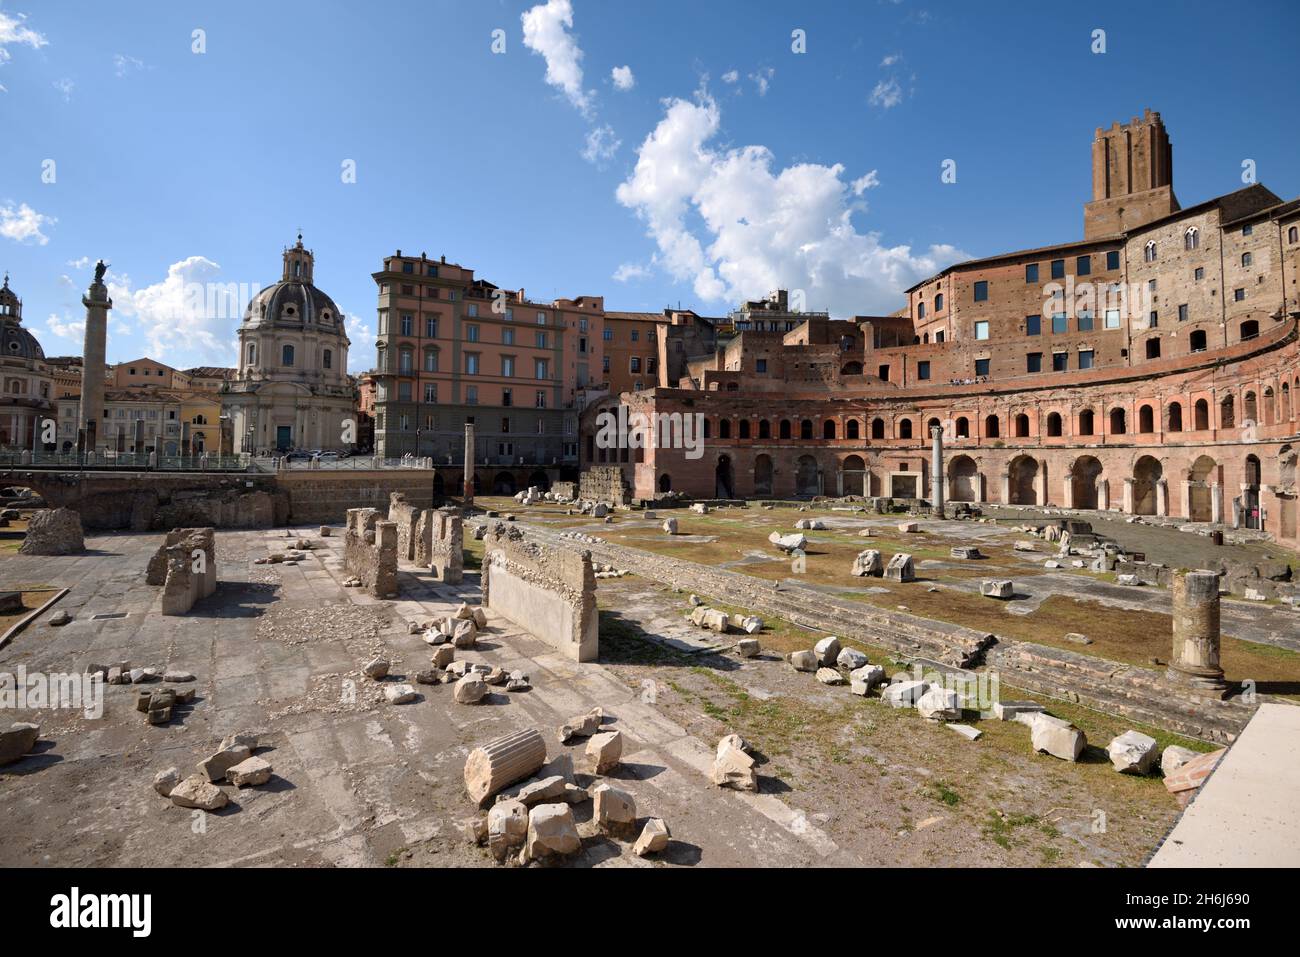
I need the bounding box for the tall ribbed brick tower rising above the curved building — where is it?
[1083,109,1179,239]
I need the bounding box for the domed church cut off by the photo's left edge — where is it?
[0,273,56,449]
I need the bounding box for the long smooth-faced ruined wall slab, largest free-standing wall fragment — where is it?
[482,523,599,662]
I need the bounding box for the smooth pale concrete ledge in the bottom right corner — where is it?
[1148,705,1300,867]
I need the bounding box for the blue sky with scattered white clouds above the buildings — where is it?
[0,0,1300,371]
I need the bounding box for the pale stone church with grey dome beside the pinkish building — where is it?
[221,233,356,452]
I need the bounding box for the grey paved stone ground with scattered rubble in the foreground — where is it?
[0,529,1196,866]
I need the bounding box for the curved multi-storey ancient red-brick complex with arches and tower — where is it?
[603,111,1300,547]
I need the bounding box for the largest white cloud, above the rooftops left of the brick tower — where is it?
[616,92,966,316]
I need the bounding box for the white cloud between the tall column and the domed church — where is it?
[107,256,240,367]
